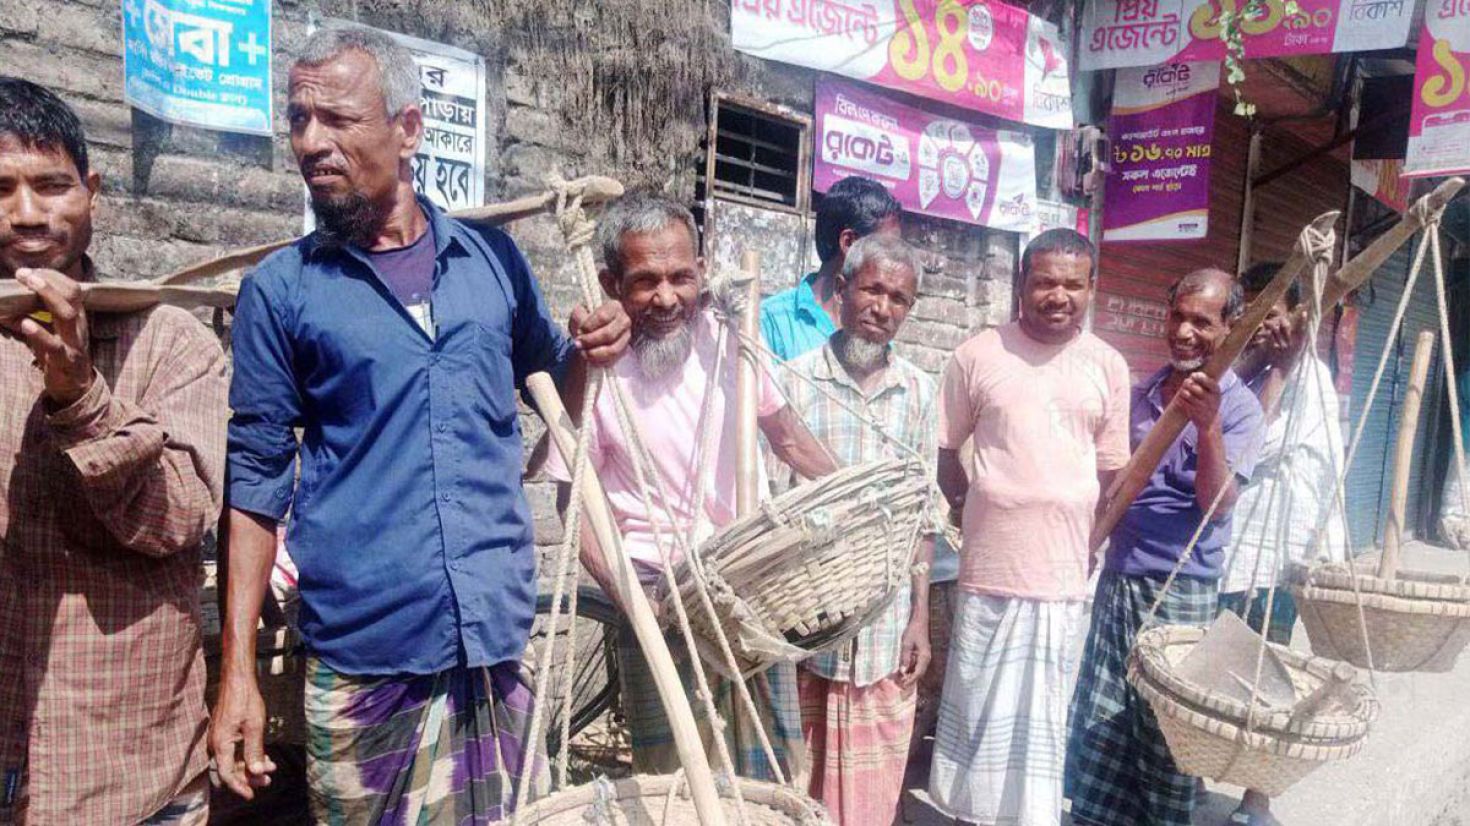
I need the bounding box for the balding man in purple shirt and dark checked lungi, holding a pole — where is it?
[1066,269,1263,826]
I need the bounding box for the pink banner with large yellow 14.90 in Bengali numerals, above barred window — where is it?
[731,0,1072,129]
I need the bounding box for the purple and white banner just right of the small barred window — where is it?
[811,79,1036,232]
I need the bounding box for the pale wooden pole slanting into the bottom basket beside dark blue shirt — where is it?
[526,373,725,826]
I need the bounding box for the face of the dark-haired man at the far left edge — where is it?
[0,135,101,278]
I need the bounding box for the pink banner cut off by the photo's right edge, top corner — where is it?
[1404,0,1470,178]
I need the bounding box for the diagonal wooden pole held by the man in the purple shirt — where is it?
[1092,210,1338,551]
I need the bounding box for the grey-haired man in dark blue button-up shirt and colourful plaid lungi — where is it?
[210,28,631,823]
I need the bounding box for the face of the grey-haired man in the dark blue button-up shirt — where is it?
[287,49,423,238]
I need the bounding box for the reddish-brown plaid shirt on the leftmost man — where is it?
[0,295,226,825]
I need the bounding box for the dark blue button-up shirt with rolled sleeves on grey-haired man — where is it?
[228,200,573,675]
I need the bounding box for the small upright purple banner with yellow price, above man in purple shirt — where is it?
[1103,63,1220,241]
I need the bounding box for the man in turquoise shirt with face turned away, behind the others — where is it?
[760,176,903,362]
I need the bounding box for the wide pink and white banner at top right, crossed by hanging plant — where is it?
[1078,0,1411,71]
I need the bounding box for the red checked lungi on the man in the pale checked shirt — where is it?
[797,670,917,826]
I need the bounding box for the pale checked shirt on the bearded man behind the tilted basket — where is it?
[772,338,942,686]
